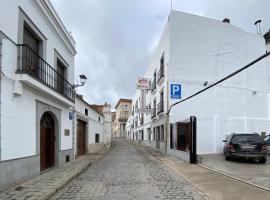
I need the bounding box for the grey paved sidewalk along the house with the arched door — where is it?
[0,148,111,200]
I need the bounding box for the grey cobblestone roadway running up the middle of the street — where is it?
[51,140,207,200]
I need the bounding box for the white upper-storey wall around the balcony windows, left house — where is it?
[0,0,74,83]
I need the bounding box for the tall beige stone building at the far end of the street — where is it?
[113,99,132,138]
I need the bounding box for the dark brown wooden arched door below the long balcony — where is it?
[40,112,55,171]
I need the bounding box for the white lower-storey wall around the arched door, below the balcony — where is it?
[1,40,72,160]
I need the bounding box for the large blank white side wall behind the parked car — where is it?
[169,12,270,154]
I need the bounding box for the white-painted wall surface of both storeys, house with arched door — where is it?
[0,0,75,160]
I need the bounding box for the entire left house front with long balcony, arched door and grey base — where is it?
[0,0,76,190]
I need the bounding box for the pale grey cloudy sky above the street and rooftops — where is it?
[51,0,270,106]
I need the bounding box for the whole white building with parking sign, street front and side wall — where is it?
[126,11,270,159]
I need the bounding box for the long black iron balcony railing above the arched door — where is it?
[16,44,75,102]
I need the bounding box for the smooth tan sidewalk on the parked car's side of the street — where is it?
[141,147,270,200]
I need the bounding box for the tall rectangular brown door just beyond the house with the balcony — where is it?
[77,120,86,156]
